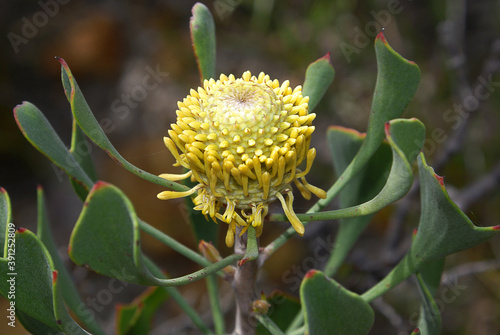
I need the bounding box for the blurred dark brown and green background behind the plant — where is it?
[0,0,500,335]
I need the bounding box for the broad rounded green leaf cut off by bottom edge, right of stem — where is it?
[300,270,374,335]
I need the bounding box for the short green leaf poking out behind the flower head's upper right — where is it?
[303,53,335,112]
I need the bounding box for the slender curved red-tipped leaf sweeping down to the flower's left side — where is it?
[58,58,188,192]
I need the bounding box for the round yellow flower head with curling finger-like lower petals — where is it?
[158,71,326,246]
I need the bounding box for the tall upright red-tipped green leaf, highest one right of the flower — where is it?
[311,32,420,212]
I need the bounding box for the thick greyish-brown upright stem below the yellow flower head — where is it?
[233,229,258,335]
